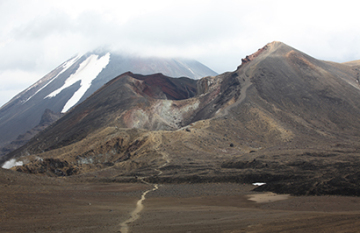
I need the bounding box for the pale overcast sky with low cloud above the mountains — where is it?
[0,0,360,106]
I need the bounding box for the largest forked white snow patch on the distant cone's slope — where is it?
[45,53,110,113]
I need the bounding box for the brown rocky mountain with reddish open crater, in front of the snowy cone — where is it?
[2,42,360,195]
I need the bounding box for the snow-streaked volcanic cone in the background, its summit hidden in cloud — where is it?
[0,52,216,156]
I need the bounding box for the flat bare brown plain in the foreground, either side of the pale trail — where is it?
[0,179,360,233]
